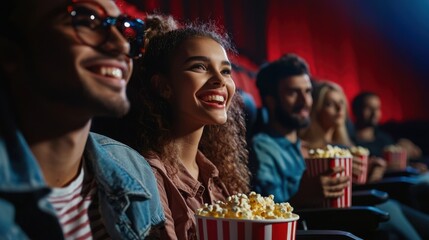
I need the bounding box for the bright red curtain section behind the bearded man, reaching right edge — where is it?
[266,0,429,121]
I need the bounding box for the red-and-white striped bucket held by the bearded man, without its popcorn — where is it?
[305,157,352,208]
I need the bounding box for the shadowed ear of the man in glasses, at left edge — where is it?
[0,36,22,76]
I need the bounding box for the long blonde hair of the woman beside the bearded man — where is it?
[300,81,353,148]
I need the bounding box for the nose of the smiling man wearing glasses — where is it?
[102,26,131,56]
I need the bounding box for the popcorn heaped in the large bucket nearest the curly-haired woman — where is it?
[197,192,293,220]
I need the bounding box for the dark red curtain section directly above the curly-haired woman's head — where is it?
[120,0,267,63]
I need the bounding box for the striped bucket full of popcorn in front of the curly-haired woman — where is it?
[195,192,299,240]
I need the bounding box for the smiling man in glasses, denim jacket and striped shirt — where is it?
[0,0,164,239]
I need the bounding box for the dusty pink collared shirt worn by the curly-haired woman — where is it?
[147,152,229,240]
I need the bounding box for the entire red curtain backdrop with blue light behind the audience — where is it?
[115,0,429,151]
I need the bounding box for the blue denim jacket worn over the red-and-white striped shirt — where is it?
[0,131,165,239]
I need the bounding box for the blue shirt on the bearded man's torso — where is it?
[250,132,306,202]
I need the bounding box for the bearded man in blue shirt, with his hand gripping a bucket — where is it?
[250,54,349,207]
